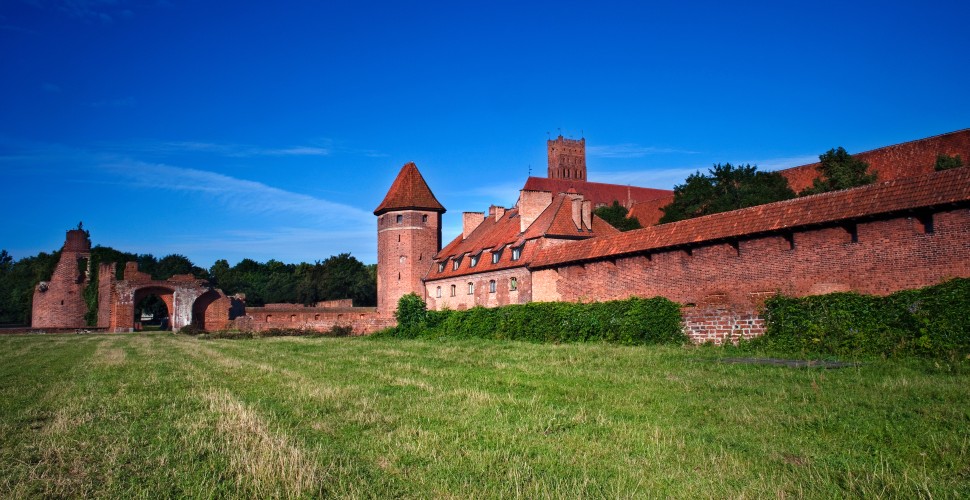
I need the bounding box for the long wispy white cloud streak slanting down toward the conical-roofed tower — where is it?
[101,160,373,226]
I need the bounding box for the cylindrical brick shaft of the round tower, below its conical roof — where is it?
[377,210,441,316]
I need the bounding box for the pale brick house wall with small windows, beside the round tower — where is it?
[425,267,532,311]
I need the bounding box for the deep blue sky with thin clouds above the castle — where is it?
[0,0,970,266]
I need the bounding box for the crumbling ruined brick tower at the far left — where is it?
[30,224,91,328]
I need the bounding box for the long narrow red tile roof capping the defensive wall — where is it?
[529,167,970,269]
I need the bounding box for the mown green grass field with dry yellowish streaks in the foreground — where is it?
[0,333,970,498]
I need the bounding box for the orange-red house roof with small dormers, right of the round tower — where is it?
[425,194,619,280]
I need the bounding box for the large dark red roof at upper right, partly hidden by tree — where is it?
[779,129,970,192]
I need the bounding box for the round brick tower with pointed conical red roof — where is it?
[374,163,445,315]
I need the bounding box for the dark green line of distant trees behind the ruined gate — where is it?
[0,245,377,325]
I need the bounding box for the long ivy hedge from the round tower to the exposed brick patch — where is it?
[381,294,687,344]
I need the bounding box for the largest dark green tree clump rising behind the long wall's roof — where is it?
[660,163,795,224]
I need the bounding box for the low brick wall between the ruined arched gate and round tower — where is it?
[228,304,397,335]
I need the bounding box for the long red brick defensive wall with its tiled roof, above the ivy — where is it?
[529,168,970,343]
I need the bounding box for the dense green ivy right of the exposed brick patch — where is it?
[749,278,970,358]
